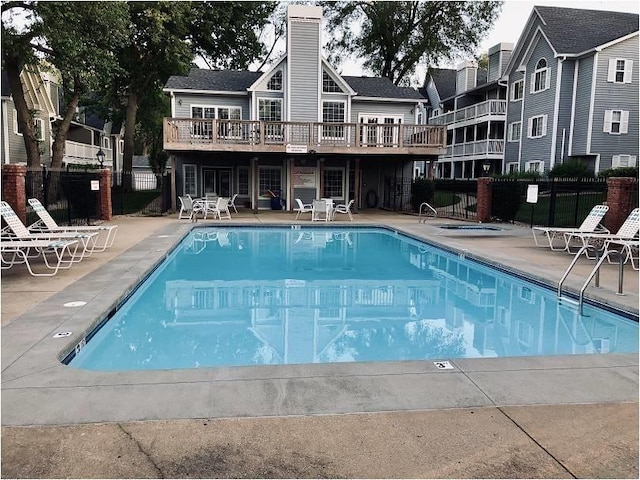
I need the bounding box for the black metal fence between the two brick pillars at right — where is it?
[491,178,607,227]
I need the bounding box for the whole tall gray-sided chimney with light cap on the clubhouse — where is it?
[286,5,322,122]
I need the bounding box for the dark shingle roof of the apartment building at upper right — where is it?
[534,6,638,54]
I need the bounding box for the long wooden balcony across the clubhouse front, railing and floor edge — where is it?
[163,118,446,155]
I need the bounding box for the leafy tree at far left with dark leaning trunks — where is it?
[2,2,127,167]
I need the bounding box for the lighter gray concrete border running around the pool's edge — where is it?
[2,222,638,425]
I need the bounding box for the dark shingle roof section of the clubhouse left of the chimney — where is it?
[165,68,262,92]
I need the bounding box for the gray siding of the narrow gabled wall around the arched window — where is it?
[521,38,557,170]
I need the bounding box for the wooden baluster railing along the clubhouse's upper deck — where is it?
[164,118,445,148]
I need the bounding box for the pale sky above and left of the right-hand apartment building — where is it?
[340,0,640,78]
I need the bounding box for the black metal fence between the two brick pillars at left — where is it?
[25,167,100,225]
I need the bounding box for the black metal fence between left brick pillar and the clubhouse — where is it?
[111,171,171,216]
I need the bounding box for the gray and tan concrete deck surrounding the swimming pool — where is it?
[1,211,639,478]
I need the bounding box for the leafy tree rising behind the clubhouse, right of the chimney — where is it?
[321,0,502,85]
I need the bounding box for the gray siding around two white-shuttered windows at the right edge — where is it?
[590,35,640,169]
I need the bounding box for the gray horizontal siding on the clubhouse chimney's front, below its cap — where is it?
[288,21,320,122]
